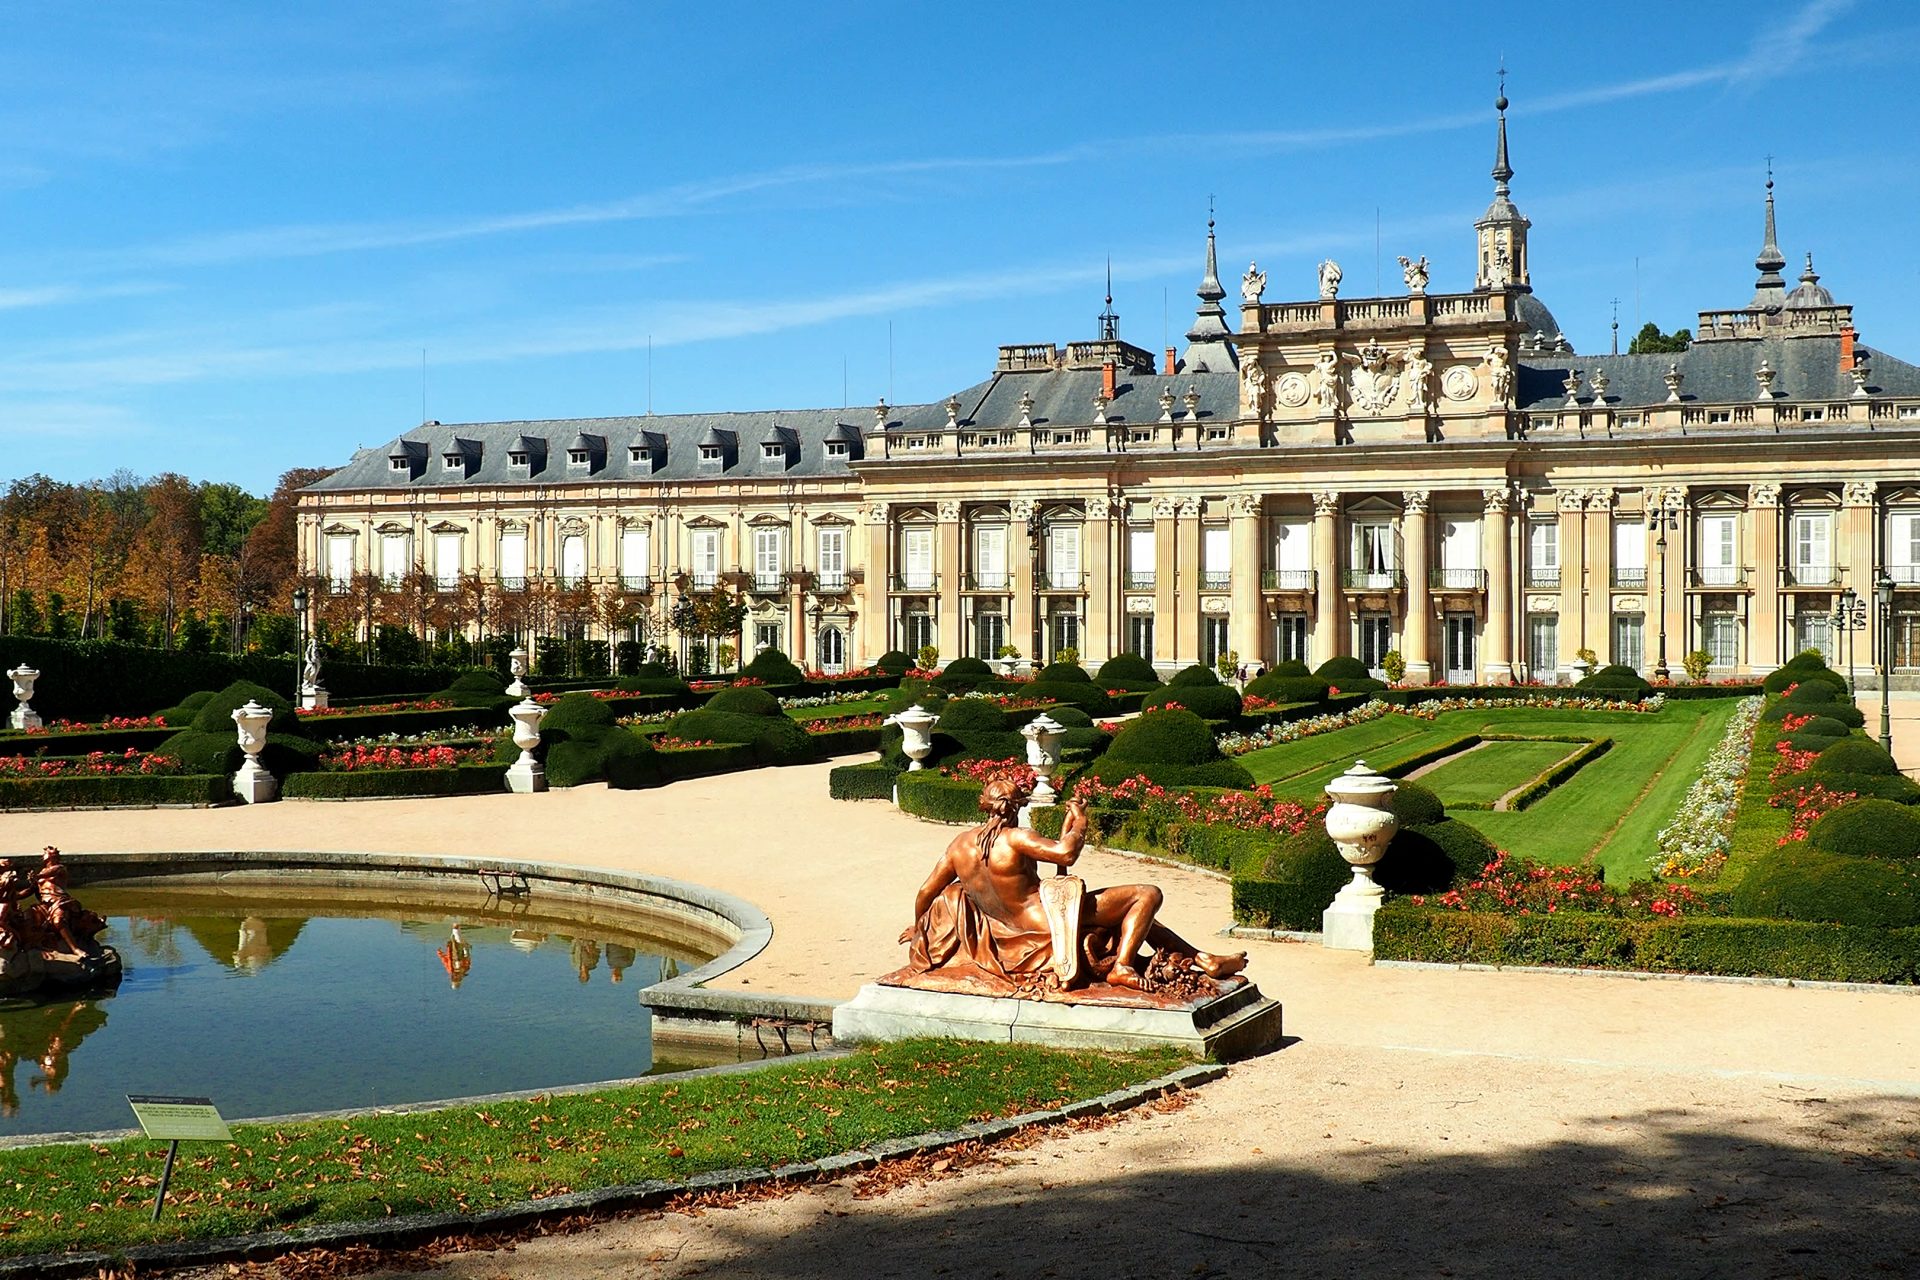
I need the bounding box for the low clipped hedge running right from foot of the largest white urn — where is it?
[1373,902,1920,983]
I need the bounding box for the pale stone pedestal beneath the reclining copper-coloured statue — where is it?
[833,979,1281,1059]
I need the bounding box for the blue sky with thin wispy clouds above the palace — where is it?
[0,0,1920,491]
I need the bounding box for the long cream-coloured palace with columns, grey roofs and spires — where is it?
[300,98,1920,683]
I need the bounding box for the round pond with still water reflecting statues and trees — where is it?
[0,879,728,1136]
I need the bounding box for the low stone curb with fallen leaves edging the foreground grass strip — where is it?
[0,1063,1227,1280]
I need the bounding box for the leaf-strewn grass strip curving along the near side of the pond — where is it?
[0,1040,1185,1255]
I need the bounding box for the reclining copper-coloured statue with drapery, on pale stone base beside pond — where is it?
[881,779,1246,1002]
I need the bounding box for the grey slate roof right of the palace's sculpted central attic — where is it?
[1517,334,1920,413]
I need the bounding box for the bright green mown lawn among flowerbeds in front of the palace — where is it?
[1240,699,1736,883]
